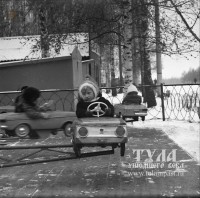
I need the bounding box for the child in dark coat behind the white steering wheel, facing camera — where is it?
[76,76,114,118]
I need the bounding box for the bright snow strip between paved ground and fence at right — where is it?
[127,120,200,163]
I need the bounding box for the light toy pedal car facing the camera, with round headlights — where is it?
[71,102,128,157]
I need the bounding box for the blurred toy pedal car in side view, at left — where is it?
[0,111,76,138]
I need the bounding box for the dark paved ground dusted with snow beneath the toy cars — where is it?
[0,128,200,198]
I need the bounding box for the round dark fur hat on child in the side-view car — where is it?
[23,87,40,103]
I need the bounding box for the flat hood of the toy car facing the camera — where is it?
[74,117,126,126]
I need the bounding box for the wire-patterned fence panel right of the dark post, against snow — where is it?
[161,84,200,122]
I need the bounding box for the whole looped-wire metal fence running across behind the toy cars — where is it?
[0,84,200,122]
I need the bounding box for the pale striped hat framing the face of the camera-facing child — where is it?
[78,75,99,98]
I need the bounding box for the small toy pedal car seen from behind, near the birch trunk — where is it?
[114,104,147,121]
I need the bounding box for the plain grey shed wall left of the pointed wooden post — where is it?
[0,57,73,91]
